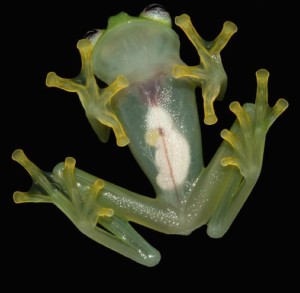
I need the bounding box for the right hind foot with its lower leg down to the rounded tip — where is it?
[207,69,288,238]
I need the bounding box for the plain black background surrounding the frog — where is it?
[0,1,299,292]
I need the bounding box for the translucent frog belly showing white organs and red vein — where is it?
[114,72,203,204]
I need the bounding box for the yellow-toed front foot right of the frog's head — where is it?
[173,14,237,125]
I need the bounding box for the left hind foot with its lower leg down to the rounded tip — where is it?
[12,149,160,267]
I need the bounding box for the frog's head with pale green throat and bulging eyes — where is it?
[88,5,182,84]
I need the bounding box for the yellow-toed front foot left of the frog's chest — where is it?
[46,39,129,146]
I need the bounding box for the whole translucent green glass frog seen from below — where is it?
[13,5,288,266]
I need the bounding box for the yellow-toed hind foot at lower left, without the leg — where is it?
[12,149,114,222]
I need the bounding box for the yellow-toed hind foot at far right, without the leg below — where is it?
[221,69,288,180]
